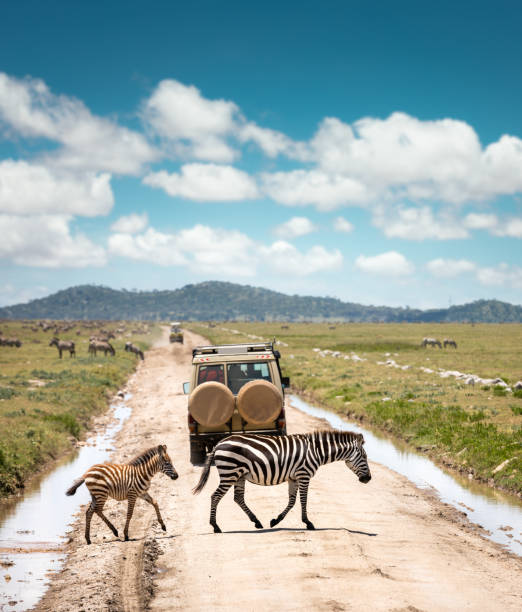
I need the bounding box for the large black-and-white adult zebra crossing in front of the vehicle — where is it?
[193,431,371,533]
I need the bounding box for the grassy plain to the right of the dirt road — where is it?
[190,322,522,494]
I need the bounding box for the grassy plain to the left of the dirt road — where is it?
[0,321,157,497]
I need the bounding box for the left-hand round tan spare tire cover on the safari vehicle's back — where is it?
[189,381,235,427]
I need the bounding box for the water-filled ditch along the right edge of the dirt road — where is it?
[290,395,522,556]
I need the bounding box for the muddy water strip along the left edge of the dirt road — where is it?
[0,394,131,612]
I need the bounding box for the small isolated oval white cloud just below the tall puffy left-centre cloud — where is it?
[143,163,259,202]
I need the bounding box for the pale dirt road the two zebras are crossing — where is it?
[37,333,522,612]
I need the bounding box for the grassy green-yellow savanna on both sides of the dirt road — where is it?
[0,321,522,495]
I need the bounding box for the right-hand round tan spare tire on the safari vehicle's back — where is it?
[237,380,283,425]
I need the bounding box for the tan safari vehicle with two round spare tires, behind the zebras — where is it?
[183,342,290,465]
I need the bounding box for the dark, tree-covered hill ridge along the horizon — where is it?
[0,281,522,323]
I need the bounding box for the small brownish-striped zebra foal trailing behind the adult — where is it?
[65,444,178,544]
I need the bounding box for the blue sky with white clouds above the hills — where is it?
[0,1,522,308]
